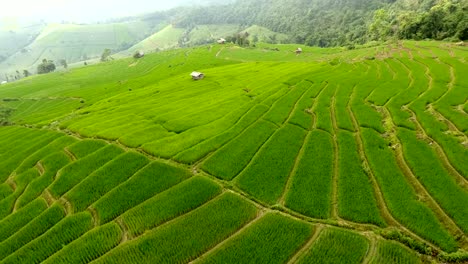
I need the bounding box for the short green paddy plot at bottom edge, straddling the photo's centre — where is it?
[201,214,313,263]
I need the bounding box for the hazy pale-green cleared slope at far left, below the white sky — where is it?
[0,21,150,76]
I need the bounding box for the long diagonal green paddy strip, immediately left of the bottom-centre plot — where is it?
[93,193,257,263]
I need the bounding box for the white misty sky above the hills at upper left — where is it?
[0,0,191,22]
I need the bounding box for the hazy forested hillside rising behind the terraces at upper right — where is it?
[169,0,468,47]
